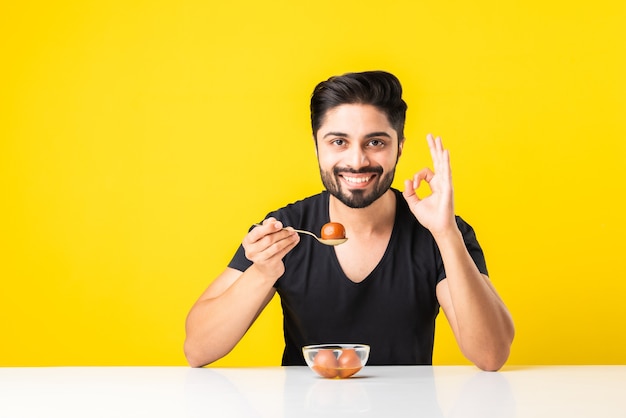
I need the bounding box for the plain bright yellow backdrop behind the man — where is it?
[0,0,626,366]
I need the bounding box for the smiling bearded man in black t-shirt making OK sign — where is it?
[185,71,514,370]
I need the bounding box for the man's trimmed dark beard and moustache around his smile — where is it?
[320,167,396,209]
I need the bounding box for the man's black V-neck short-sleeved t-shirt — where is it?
[229,189,487,366]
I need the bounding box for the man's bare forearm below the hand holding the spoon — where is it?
[184,265,275,367]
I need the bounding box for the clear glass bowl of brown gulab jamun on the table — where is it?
[302,344,370,379]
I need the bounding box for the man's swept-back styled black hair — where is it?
[311,71,407,141]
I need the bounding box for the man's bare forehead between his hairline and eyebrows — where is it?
[318,104,395,135]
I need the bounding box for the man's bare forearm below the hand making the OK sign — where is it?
[436,228,515,370]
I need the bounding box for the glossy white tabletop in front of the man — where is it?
[0,366,626,418]
